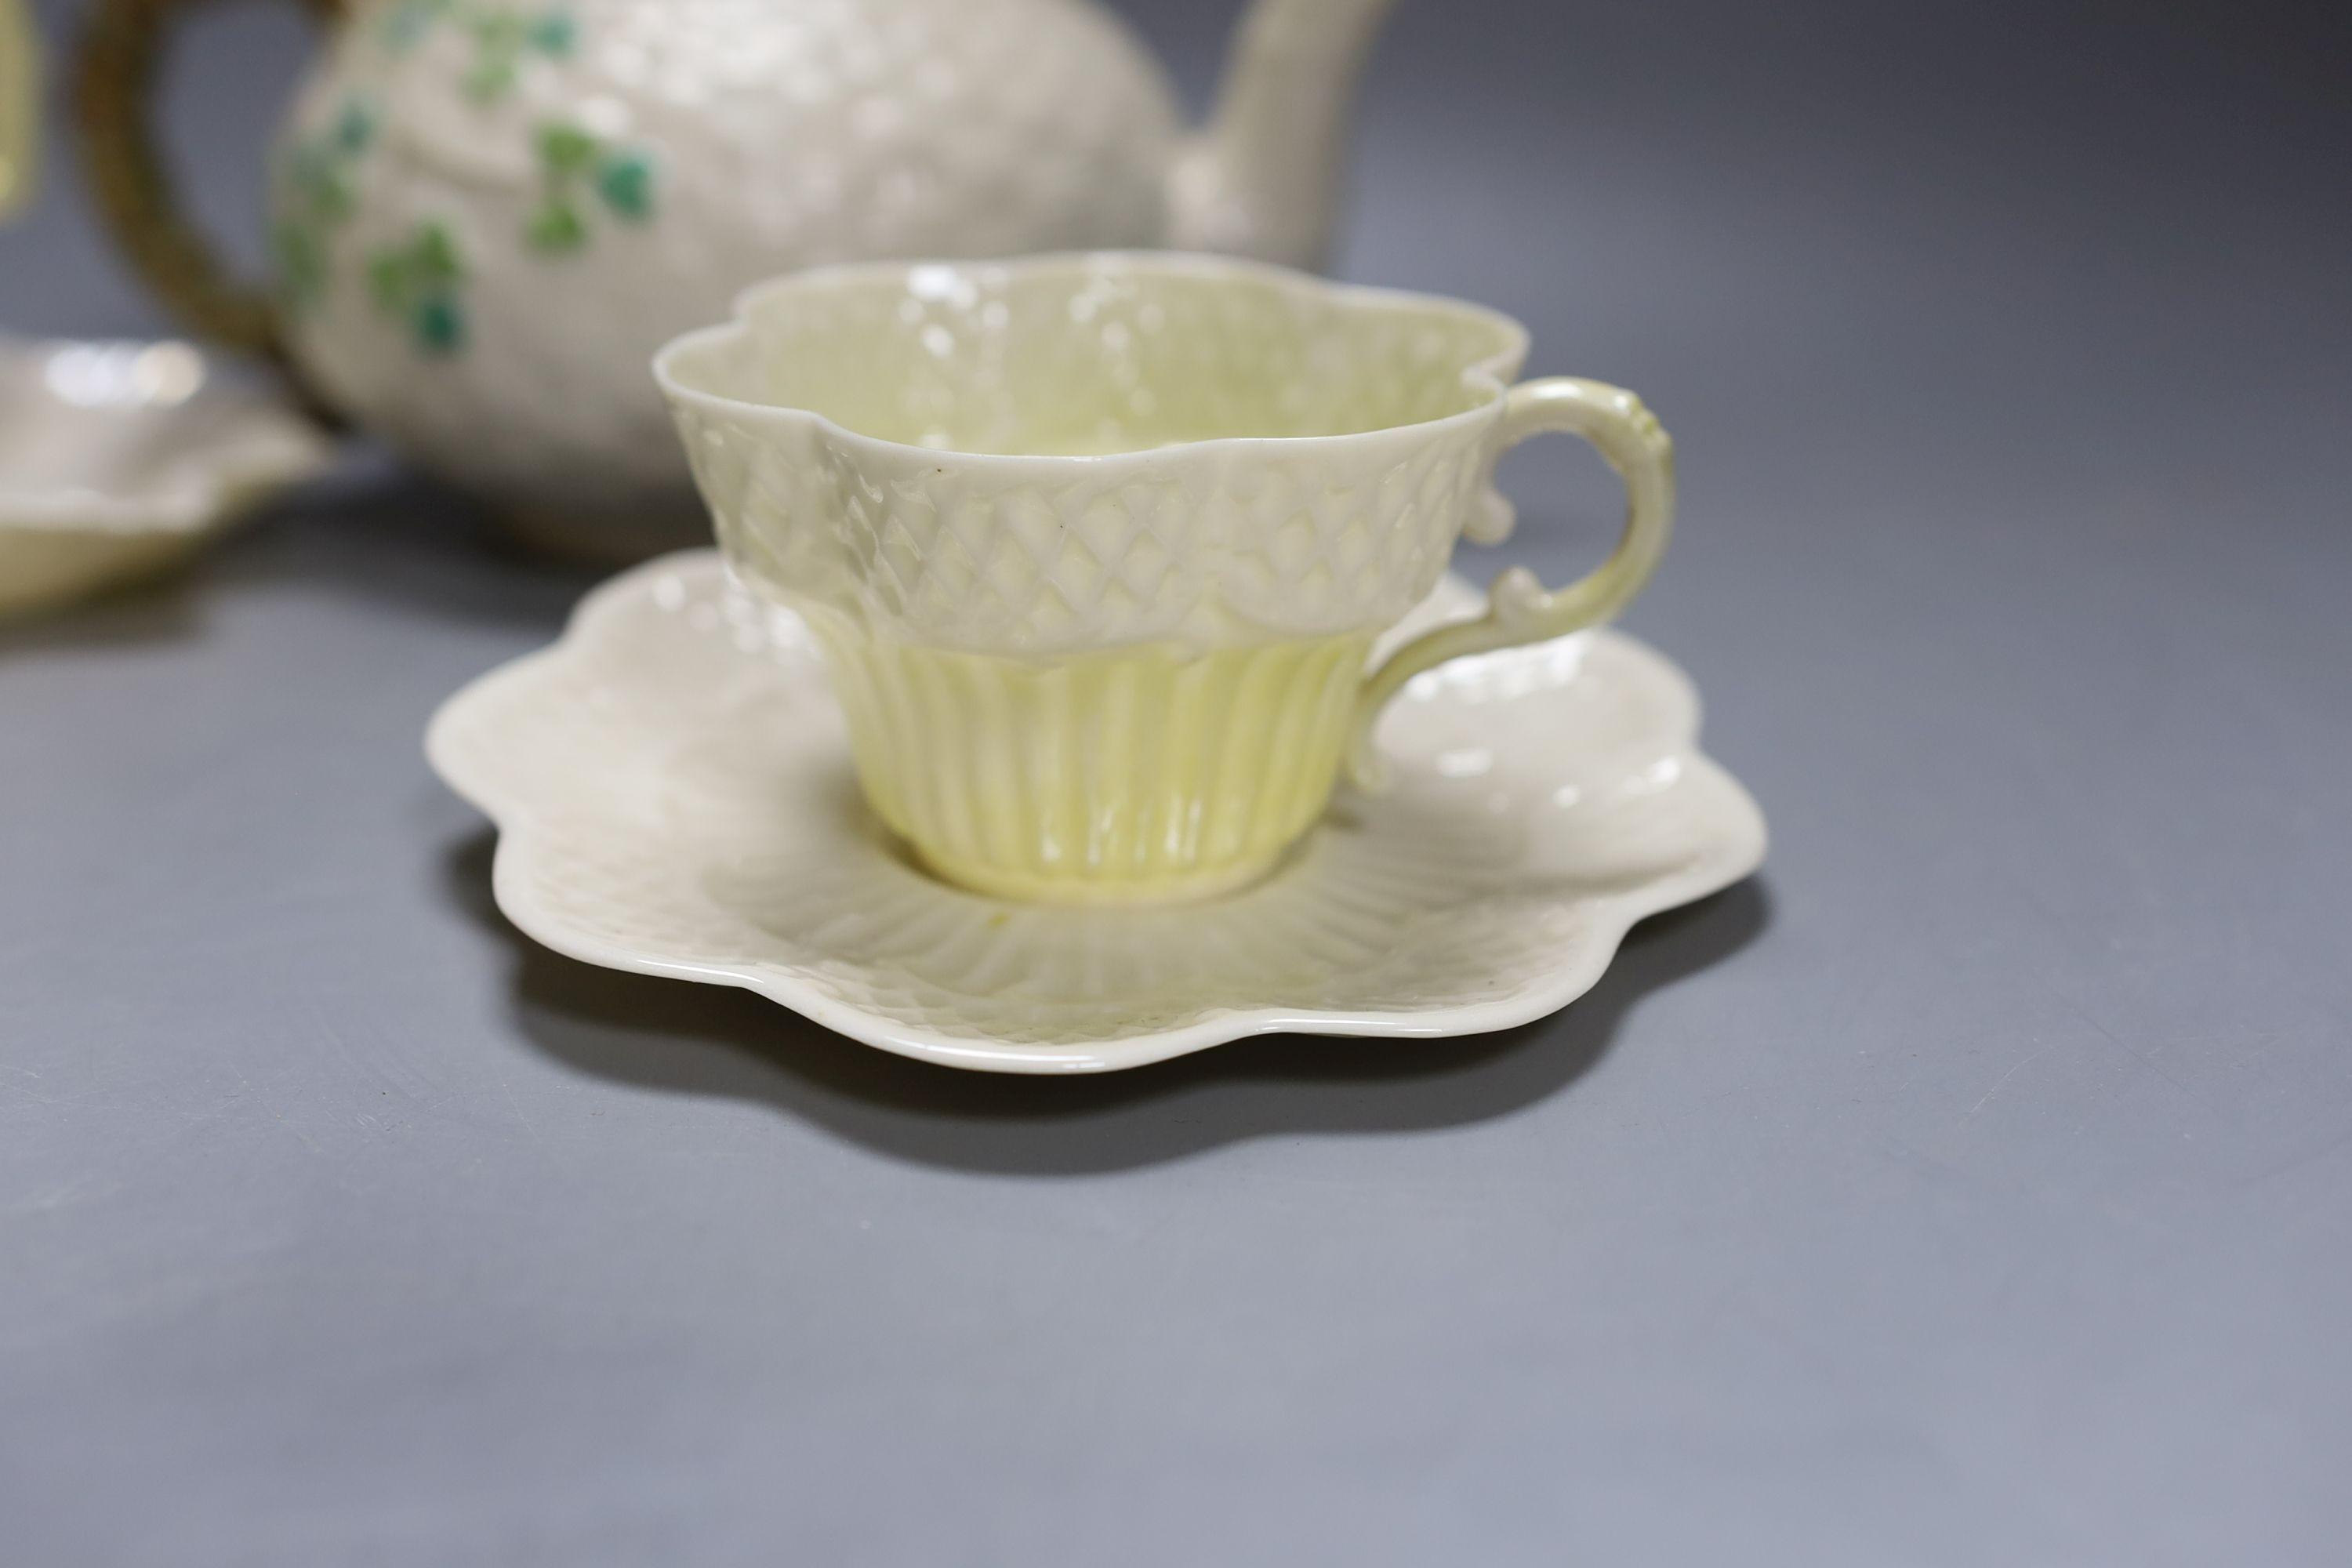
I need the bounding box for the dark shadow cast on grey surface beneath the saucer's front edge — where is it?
[445,829,1771,1175]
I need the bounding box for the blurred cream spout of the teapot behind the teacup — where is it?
[1169,0,1395,268]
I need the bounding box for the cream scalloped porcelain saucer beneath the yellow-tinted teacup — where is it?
[426,550,1764,1072]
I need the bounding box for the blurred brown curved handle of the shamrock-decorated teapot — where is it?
[73,0,346,369]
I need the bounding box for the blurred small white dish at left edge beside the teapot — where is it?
[0,336,332,616]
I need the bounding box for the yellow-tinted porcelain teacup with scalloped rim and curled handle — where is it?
[654,254,1672,902]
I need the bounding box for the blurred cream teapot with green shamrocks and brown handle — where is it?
[78,0,1392,557]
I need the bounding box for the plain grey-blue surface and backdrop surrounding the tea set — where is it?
[0,0,2352,1568]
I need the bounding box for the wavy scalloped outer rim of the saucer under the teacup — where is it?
[423,550,1769,1076]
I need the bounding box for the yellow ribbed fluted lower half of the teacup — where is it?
[821,628,1371,900]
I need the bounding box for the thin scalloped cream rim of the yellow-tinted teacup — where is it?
[654,249,1531,473]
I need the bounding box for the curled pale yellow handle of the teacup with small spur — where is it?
[1348,376,1675,789]
